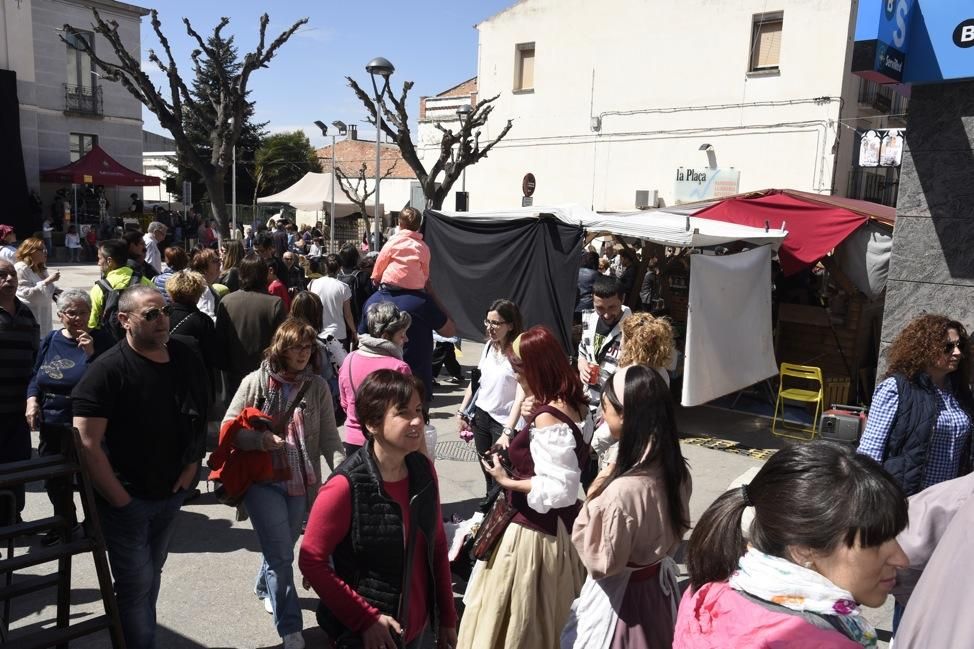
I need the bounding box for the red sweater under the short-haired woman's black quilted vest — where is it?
[298,468,457,642]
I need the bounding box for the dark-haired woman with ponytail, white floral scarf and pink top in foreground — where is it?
[673,442,909,649]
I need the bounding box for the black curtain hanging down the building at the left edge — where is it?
[0,70,31,235]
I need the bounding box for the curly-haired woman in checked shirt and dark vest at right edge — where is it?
[859,314,974,496]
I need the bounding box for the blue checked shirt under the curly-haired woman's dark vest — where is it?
[858,376,971,489]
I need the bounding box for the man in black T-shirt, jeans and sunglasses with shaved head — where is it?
[71,285,209,648]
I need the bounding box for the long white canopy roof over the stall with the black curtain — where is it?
[441,205,787,249]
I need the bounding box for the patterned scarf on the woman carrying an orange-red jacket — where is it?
[260,361,315,496]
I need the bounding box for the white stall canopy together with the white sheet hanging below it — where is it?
[442,205,787,406]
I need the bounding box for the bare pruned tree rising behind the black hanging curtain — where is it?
[345,77,513,209]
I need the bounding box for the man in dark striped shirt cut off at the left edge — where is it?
[0,259,40,525]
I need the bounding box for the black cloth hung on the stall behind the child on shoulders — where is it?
[423,210,584,355]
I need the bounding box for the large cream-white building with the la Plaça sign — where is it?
[419,0,903,211]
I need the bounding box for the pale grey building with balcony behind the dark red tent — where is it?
[0,0,149,213]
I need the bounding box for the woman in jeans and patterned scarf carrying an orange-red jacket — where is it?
[223,318,345,649]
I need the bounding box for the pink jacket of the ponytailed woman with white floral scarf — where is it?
[673,582,862,649]
